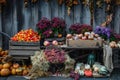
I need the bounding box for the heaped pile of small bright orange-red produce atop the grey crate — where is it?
[11,29,40,42]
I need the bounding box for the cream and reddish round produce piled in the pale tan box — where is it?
[66,32,102,40]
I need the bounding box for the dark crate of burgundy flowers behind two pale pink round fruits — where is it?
[37,17,66,46]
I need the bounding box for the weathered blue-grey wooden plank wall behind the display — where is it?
[0,0,120,49]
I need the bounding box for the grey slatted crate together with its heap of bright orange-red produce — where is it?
[9,29,40,58]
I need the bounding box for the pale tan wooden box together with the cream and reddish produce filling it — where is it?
[66,32,102,48]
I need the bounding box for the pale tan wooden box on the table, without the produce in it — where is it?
[66,39,102,48]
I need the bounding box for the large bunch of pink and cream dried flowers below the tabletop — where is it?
[28,46,75,79]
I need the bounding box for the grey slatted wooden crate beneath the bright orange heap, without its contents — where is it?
[9,41,40,57]
